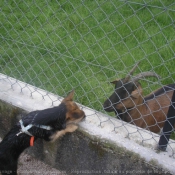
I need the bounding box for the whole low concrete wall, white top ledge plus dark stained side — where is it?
[0,74,175,174]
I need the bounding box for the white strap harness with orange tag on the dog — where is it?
[16,120,52,146]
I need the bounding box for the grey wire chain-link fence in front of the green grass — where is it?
[0,0,175,156]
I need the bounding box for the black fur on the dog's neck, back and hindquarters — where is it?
[0,103,67,175]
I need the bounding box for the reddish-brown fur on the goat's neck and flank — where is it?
[121,91,173,133]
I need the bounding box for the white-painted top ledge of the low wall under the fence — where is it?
[0,74,175,174]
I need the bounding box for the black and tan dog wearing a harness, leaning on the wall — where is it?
[0,91,85,175]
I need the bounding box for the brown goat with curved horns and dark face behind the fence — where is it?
[103,63,175,133]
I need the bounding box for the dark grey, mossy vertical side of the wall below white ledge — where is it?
[0,101,170,174]
